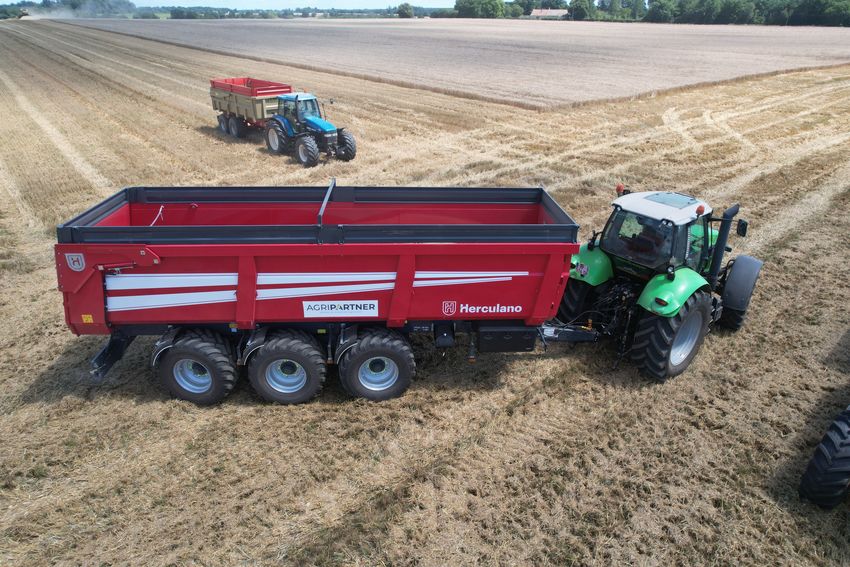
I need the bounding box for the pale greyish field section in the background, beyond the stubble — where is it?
[71,19,850,108]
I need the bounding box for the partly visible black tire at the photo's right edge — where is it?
[800,408,850,510]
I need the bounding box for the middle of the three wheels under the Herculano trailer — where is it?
[248,330,327,404]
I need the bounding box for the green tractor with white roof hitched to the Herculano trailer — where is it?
[558,184,762,381]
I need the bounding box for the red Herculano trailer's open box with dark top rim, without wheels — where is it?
[56,186,578,334]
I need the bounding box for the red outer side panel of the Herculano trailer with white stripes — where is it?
[56,243,578,334]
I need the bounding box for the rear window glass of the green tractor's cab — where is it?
[599,209,673,269]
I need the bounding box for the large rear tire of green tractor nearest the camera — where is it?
[631,291,711,382]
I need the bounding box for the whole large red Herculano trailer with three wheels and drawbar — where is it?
[56,182,596,404]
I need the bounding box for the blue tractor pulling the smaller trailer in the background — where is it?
[265,93,357,167]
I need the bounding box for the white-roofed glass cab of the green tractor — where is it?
[599,189,717,279]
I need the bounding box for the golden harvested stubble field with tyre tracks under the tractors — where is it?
[0,21,850,565]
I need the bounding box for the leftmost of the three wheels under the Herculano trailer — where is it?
[156,329,237,406]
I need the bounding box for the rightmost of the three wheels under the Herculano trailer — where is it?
[339,329,416,401]
